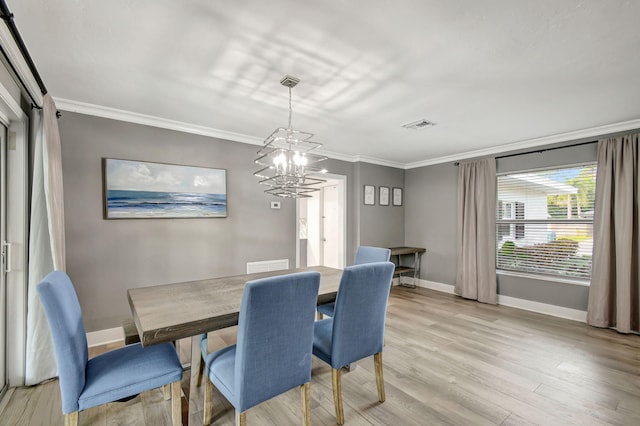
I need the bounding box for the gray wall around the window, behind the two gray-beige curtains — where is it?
[405,144,597,310]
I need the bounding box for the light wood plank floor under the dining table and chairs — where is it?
[0,287,640,426]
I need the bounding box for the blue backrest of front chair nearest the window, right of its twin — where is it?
[331,262,395,368]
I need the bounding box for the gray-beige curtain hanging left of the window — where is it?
[455,158,497,304]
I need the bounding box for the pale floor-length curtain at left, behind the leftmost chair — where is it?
[25,94,65,385]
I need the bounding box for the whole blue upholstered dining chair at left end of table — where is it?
[37,271,182,426]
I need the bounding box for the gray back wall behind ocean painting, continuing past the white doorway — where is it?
[58,112,404,331]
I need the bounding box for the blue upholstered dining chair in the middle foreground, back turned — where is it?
[204,272,320,425]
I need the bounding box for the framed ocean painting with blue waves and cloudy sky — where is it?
[102,158,227,219]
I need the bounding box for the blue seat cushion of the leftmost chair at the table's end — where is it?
[78,343,182,410]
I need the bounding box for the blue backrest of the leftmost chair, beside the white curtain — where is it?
[37,271,88,413]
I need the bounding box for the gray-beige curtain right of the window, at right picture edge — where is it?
[587,134,640,333]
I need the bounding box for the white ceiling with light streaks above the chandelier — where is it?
[7,0,640,167]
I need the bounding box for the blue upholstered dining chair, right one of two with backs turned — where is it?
[313,262,395,425]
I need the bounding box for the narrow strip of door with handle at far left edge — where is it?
[0,124,10,397]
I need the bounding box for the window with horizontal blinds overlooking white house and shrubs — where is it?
[496,163,596,280]
